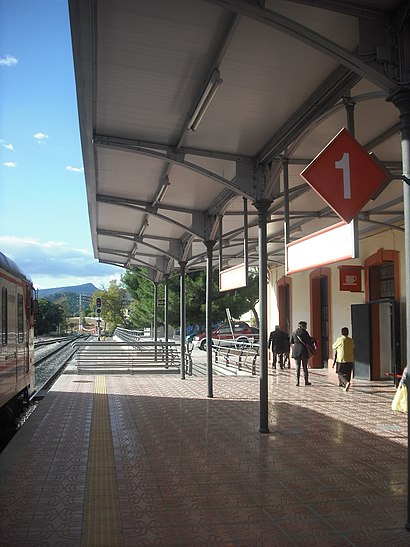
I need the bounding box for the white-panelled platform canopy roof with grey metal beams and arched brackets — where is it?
[69,0,410,281]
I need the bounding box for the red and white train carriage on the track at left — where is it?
[0,252,36,430]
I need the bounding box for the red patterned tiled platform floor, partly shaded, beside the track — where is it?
[0,362,410,547]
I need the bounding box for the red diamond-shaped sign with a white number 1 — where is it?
[301,129,390,222]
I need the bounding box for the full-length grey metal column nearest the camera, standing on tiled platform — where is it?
[253,199,271,433]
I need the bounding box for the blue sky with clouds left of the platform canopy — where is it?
[0,0,124,289]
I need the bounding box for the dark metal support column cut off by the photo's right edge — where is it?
[391,89,410,530]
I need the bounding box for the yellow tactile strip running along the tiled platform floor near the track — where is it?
[81,376,123,547]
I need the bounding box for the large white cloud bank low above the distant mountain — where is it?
[0,236,124,289]
